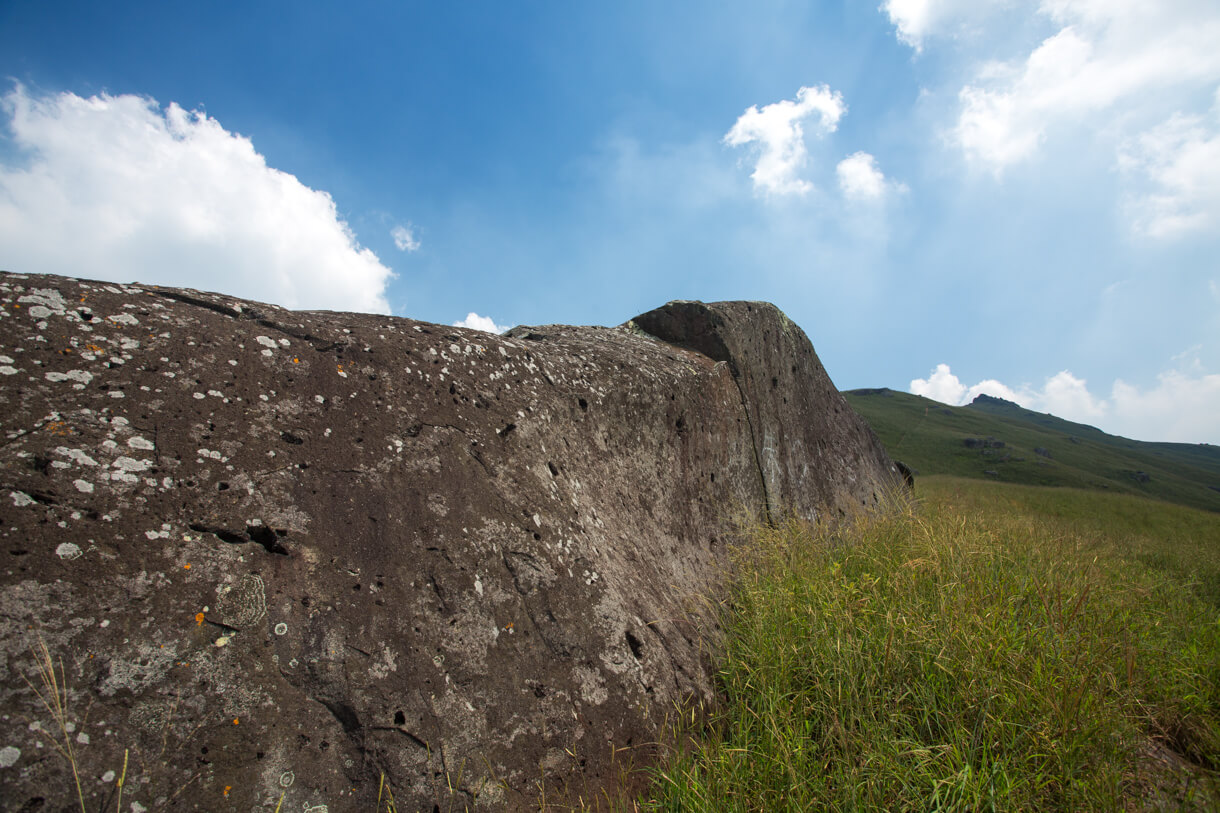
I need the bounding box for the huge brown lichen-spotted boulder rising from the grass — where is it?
[0,275,897,811]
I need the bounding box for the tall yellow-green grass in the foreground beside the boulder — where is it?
[643,479,1220,811]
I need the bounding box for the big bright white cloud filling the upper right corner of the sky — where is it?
[936,0,1220,173]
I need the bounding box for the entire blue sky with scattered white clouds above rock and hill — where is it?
[0,0,1220,443]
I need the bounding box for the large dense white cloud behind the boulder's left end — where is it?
[0,85,393,313]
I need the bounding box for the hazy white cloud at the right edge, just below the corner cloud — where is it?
[1119,103,1220,237]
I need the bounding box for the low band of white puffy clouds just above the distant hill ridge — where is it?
[910,364,1220,443]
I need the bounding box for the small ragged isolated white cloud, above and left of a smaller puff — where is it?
[723,84,847,195]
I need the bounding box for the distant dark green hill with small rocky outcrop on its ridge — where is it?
[844,389,1220,511]
